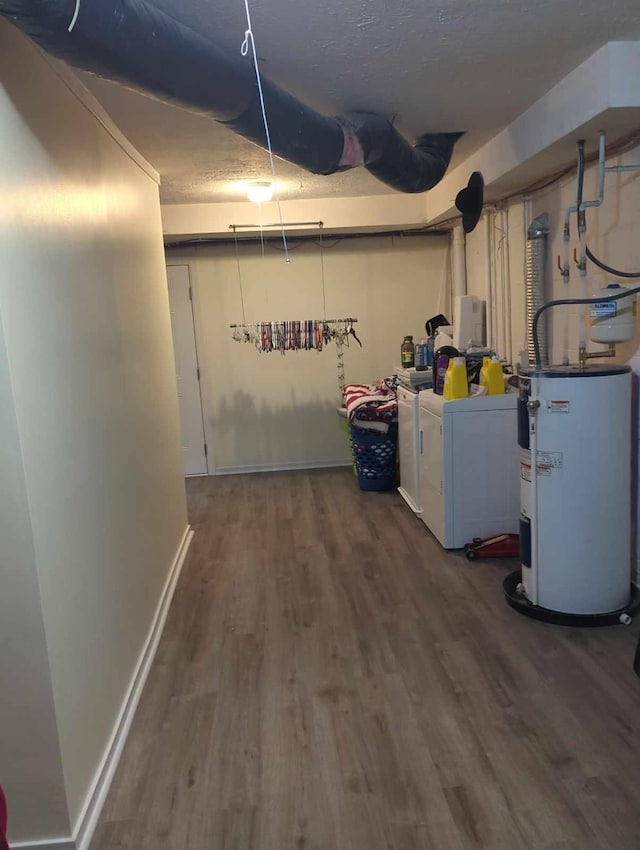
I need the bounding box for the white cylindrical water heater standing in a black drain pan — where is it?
[504,365,631,625]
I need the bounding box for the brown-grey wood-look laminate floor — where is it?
[92,470,640,850]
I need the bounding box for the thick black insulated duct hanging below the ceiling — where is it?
[0,0,461,192]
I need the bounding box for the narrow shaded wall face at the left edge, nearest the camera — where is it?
[0,314,69,838]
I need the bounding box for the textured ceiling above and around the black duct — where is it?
[83,0,640,203]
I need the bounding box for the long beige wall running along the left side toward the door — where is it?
[0,22,187,841]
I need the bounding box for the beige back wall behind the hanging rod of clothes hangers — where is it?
[169,236,449,472]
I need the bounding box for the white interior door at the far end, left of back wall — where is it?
[167,265,208,475]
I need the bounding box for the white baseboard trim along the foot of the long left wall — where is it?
[11,526,193,850]
